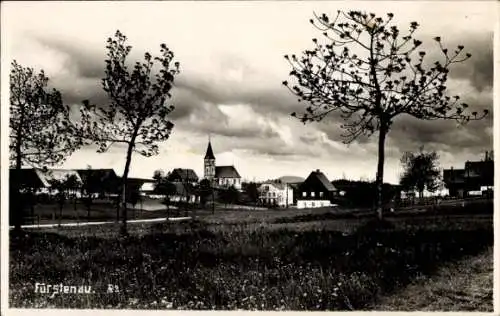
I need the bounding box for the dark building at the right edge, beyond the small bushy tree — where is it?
[443,151,494,197]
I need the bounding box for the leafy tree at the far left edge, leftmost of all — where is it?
[9,60,82,230]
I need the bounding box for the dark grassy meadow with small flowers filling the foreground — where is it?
[9,199,493,311]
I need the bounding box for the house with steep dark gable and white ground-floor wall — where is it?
[297,169,337,208]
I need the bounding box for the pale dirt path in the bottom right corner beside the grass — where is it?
[373,248,493,312]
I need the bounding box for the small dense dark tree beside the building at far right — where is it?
[400,147,441,198]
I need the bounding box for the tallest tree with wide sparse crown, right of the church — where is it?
[283,11,488,219]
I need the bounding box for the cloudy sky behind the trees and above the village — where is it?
[2,1,497,183]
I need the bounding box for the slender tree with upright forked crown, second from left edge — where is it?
[81,31,183,235]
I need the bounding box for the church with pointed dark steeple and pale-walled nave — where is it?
[203,140,241,190]
